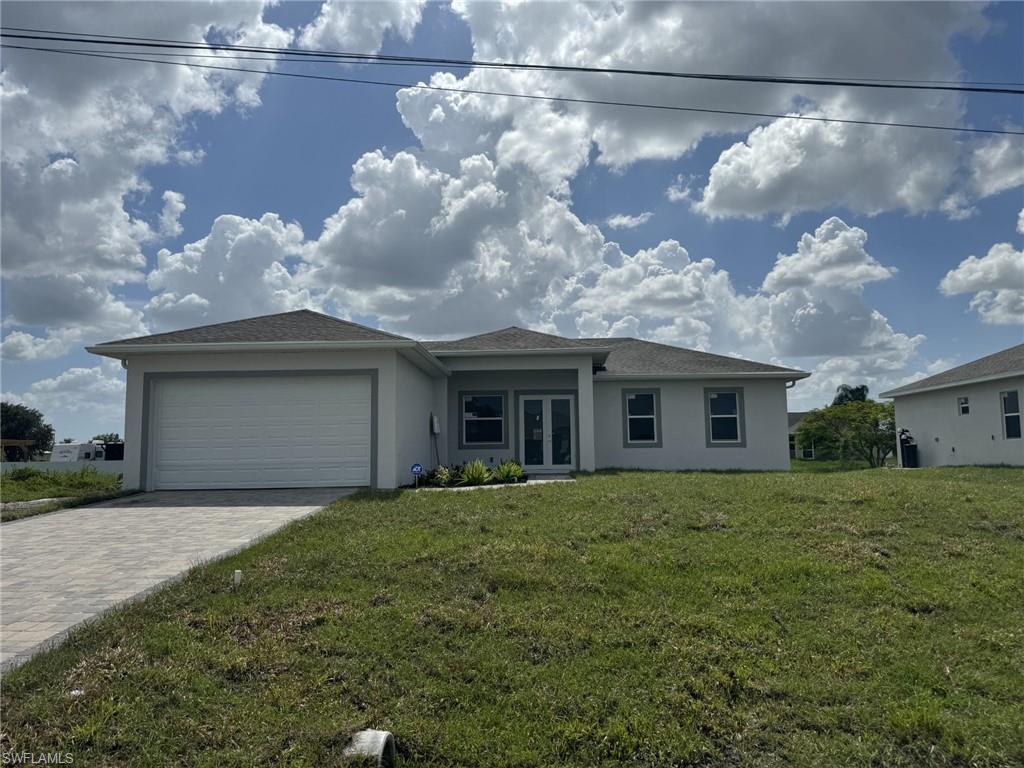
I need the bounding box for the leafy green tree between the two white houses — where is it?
[797,400,896,467]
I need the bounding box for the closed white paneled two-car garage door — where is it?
[150,375,371,489]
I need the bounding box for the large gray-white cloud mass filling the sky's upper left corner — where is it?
[0,2,291,352]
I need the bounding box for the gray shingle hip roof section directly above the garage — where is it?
[97,309,409,347]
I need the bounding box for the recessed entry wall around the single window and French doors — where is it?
[445,368,590,464]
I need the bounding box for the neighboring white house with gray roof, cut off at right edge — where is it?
[881,344,1024,467]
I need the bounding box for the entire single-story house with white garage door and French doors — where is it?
[89,310,808,489]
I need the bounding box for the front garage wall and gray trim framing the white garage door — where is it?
[124,350,403,489]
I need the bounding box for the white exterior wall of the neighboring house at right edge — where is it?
[894,376,1024,467]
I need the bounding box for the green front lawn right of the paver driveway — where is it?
[2,468,1024,768]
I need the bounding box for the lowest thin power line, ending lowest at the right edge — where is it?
[0,43,1024,136]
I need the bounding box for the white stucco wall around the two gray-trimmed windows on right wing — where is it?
[594,379,790,470]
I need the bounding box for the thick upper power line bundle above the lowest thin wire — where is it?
[0,27,1024,95]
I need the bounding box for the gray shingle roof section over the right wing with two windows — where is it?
[598,339,803,377]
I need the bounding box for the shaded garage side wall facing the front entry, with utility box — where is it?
[395,355,440,485]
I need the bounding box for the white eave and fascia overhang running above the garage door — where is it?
[85,339,452,376]
